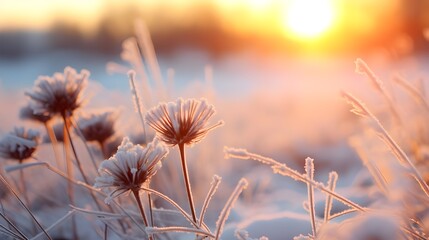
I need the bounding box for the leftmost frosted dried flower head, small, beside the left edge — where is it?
[0,127,39,162]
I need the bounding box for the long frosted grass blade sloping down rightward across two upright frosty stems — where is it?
[224,147,366,212]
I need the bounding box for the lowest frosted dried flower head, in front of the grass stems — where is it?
[94,138,168,204]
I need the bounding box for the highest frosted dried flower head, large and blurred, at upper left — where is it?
[25,67,89,116]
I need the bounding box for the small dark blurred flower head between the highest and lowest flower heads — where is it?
[79,112,117,144]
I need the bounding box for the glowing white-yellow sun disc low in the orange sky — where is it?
[283,0,335,38]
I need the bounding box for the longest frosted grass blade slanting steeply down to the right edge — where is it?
[342,92,429,197]
